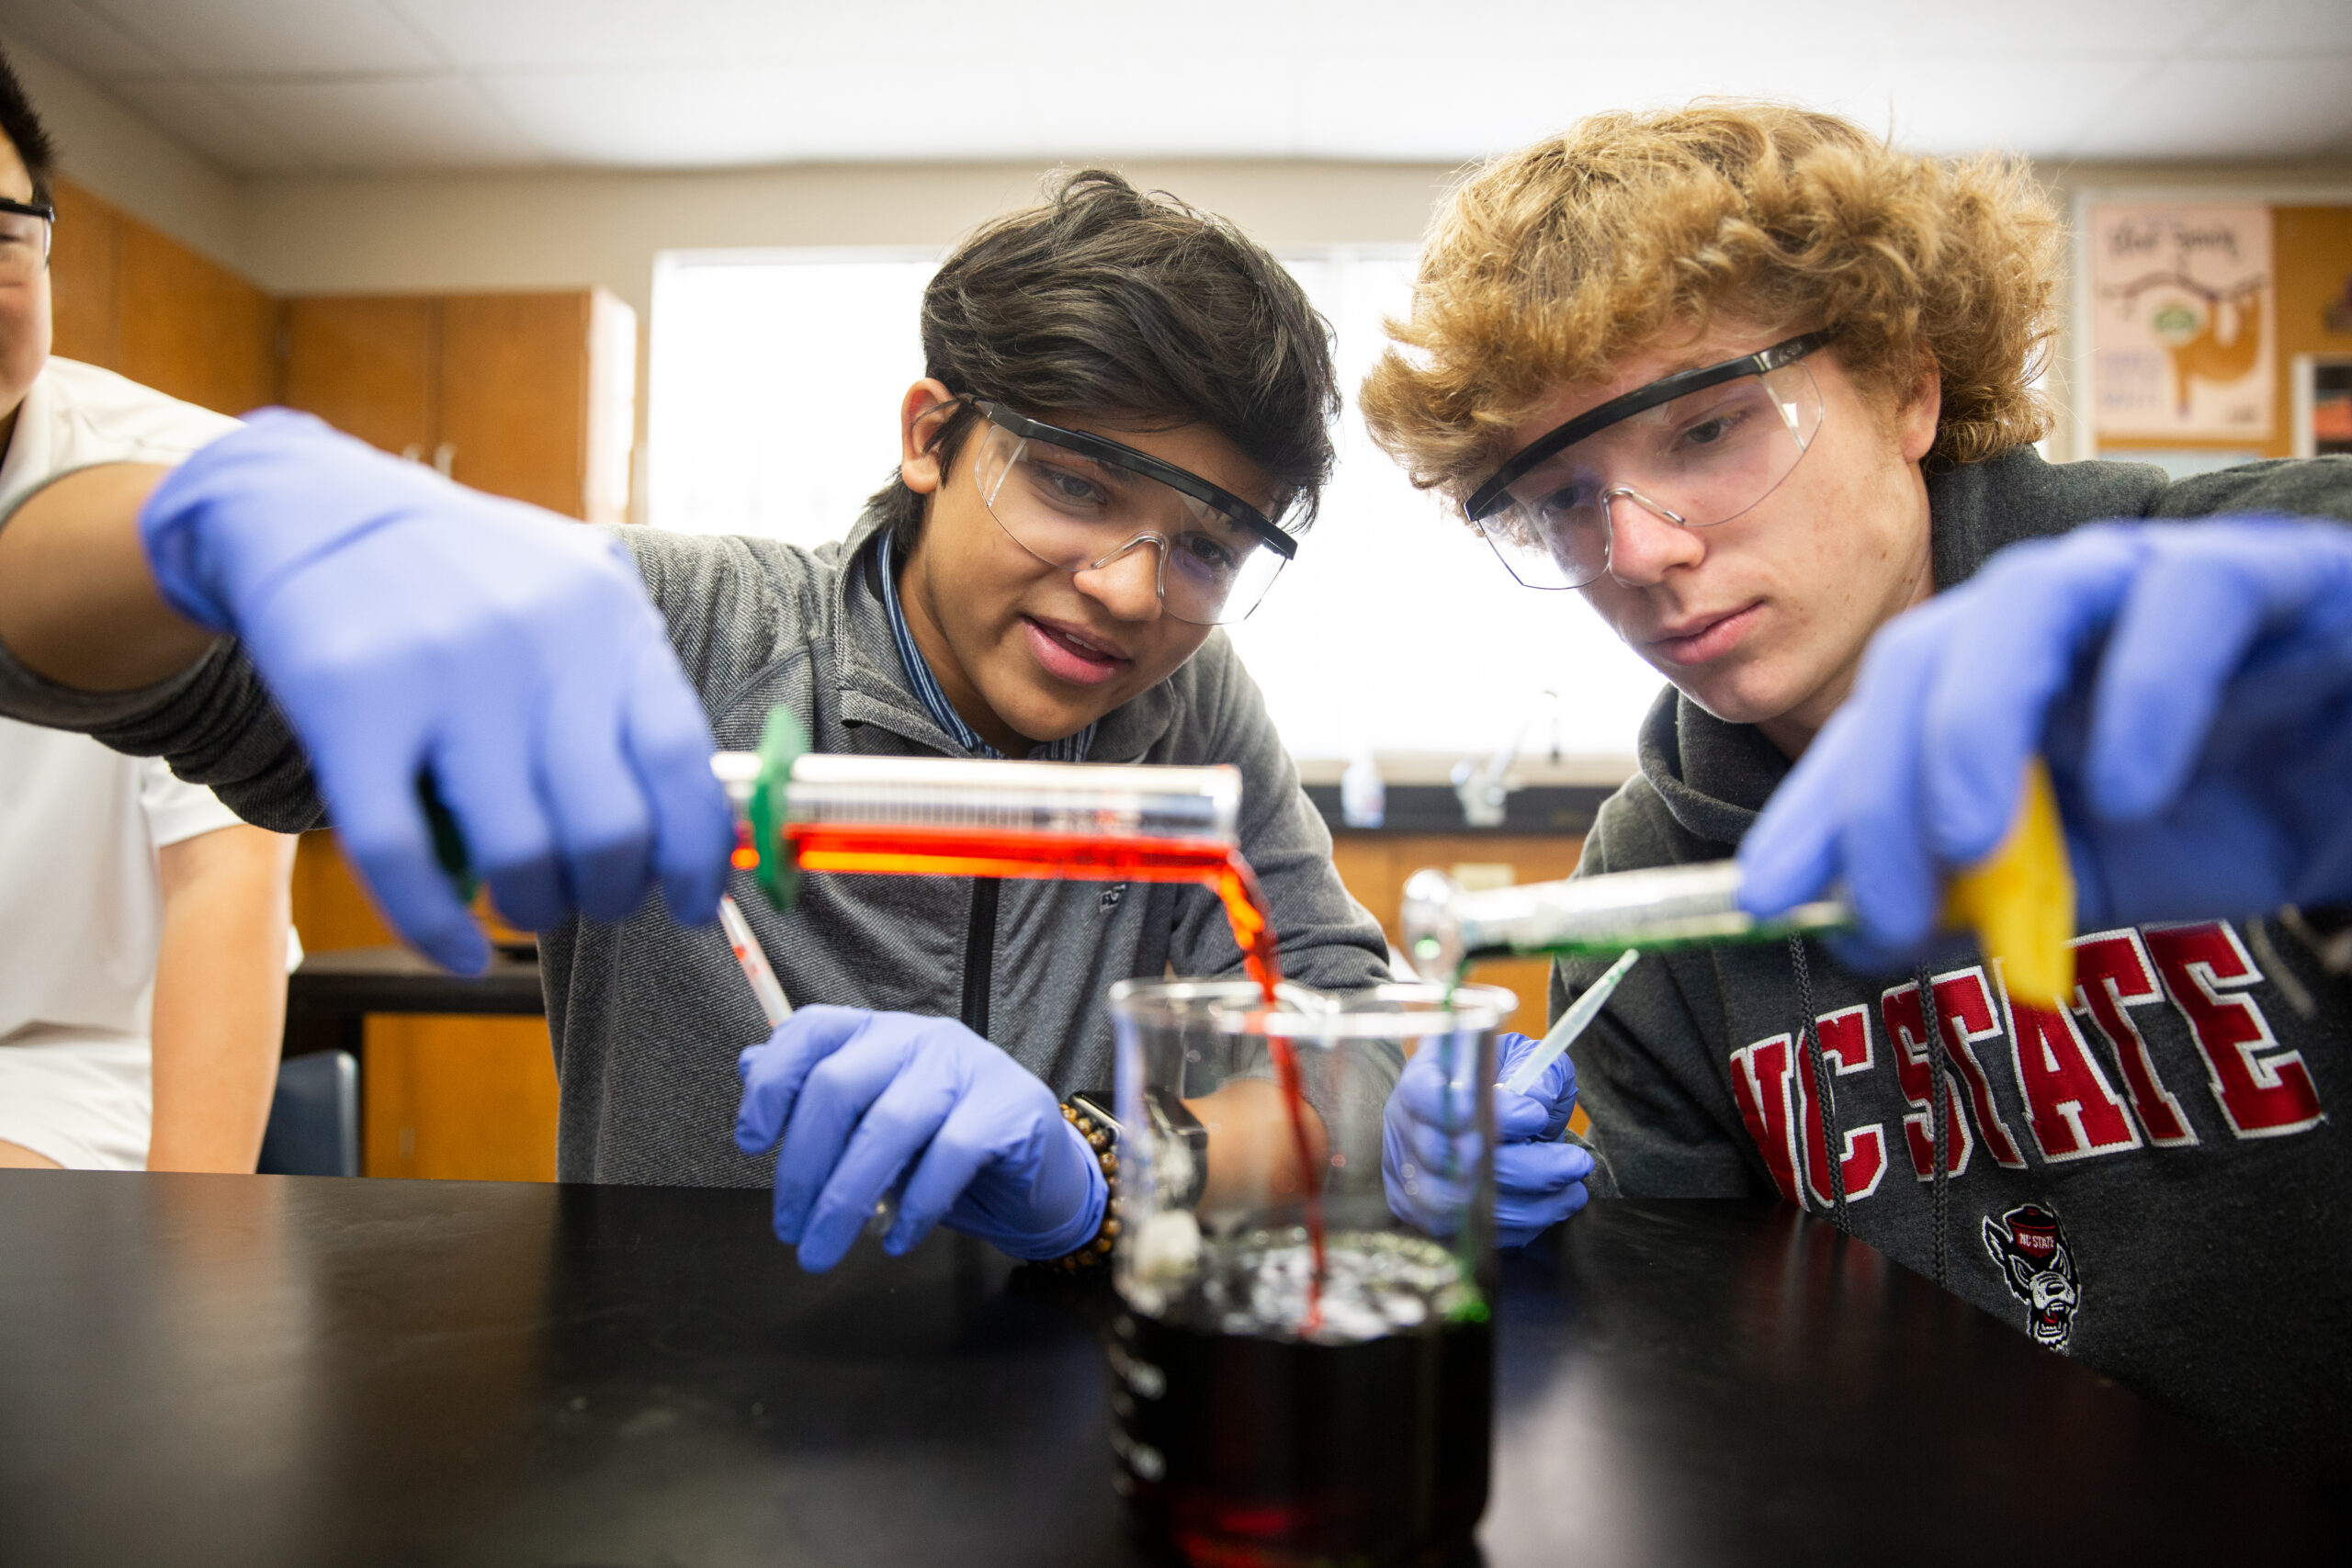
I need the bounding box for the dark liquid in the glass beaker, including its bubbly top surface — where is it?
[1110,1229,1494,1568]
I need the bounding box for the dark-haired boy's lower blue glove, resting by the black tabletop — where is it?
[736,1006,1110,1274]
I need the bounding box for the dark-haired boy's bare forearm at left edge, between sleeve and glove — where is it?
[0,463,211,691]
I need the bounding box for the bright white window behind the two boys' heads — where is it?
[647,247,1658,757]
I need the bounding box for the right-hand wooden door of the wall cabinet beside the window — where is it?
[440,289,591,517]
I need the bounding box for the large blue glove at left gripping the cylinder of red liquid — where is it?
[139,409,734,971]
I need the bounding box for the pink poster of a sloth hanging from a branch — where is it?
[2084,205,2277,442]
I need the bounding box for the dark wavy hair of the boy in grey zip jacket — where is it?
[870,169,1340,550]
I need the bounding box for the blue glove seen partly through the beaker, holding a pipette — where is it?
[1381,1034,1592,1246]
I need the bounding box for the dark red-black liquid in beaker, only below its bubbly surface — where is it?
[1113,1314,1494,1568]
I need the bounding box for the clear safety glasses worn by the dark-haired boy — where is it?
[971,402,1298,626]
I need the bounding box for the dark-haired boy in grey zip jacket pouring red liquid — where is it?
[0,172,1385,1267]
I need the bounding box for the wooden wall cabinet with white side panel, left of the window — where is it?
[285,289,638,522]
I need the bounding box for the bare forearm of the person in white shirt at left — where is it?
[148,828,294,1170]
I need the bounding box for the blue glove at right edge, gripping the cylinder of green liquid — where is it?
[1740,520,2352,957]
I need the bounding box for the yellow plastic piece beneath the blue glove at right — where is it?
[1943,757,2075,1010]
